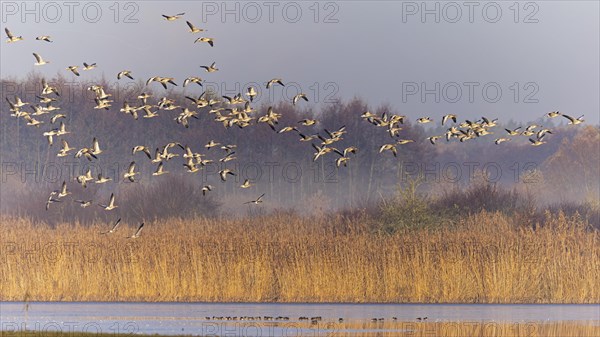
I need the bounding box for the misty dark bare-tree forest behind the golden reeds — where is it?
[0,74,600,220]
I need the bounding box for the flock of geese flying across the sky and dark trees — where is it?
[5,17,584,239]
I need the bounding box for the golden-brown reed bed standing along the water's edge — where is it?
[0,213,600,303]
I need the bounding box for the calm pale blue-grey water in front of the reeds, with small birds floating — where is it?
[0,302,600,336]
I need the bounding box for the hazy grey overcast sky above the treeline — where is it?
[1,1,600,124]
